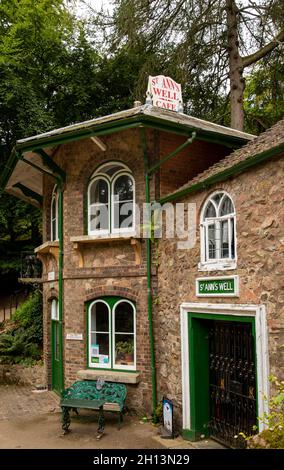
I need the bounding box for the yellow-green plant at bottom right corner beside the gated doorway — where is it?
[247,376,284,449]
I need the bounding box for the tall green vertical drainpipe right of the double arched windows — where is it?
[140,127,158,423]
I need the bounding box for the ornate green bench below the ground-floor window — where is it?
[60,380,126,437]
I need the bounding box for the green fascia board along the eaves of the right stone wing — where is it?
[159,143,284,204]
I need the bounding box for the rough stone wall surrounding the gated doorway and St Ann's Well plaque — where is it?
[155,153,284,426]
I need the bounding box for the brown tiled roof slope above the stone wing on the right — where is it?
[162,119,284,202]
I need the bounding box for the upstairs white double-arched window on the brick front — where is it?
[88,162,135,235]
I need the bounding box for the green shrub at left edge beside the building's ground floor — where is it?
[0,290,43,364]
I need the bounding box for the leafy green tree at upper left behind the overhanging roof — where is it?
[0,0,102,277]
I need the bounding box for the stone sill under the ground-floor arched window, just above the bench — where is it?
[77,369,140,384]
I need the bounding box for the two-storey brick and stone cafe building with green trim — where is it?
[1,106,284,445]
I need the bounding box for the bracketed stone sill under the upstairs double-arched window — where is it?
[70,232,141,268]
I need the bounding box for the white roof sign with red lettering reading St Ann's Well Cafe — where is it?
[146,75,183,113]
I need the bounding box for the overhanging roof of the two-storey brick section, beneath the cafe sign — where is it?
[0,105,254,205]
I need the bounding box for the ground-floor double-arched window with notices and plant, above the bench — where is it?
[88,297,136,370]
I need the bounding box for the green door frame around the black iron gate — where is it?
[183,312,258,441]
